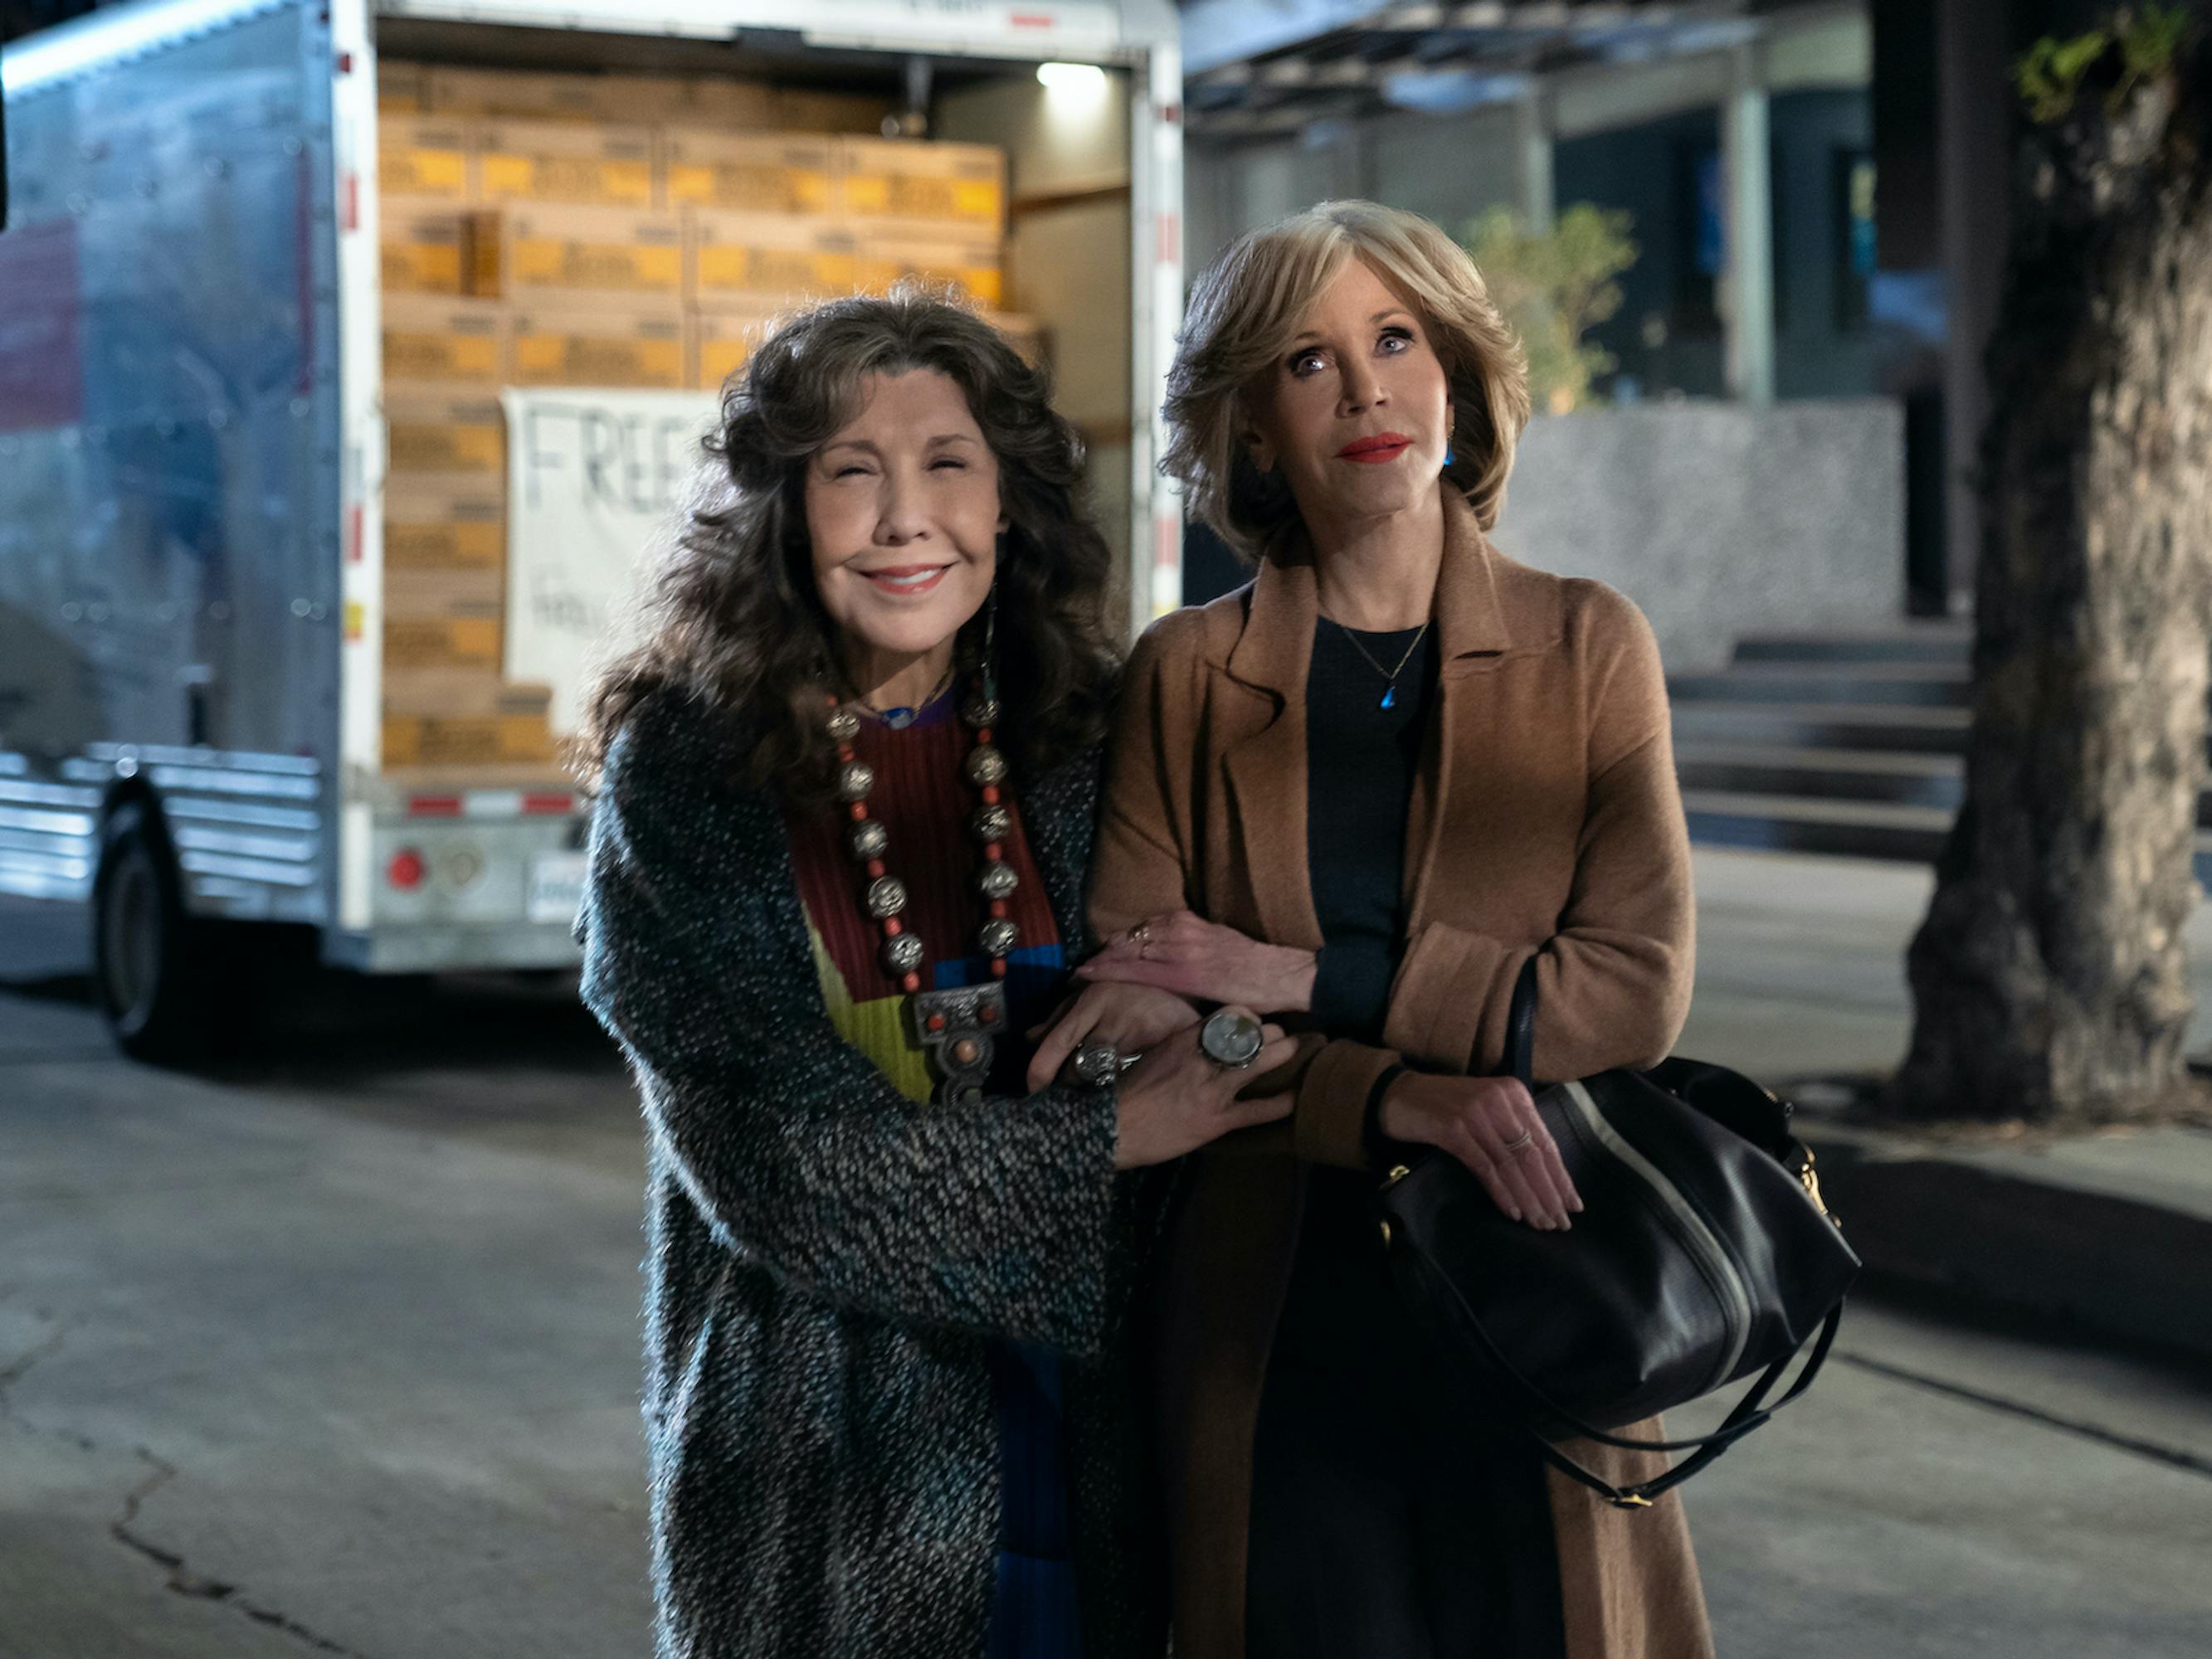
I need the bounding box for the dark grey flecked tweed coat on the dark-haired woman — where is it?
[577,694,1166,1659]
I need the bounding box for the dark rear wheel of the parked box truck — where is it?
[93,803,222,1062]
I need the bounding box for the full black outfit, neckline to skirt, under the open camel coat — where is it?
[1245,620,1566,1659]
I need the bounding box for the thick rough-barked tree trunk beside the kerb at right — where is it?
[1889,49,2212,1121]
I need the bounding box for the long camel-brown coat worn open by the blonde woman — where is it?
[1090,491,1712,1659]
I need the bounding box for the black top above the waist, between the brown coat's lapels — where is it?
[1305,617,1438,1042]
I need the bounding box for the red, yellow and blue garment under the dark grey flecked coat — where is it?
[787,688,1079,1659]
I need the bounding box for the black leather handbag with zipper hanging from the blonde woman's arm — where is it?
[1378,962,1858,1509]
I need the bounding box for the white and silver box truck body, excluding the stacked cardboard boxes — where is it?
[0,0,1182,1058]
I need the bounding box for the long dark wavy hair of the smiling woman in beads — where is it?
[575,285,1119,803]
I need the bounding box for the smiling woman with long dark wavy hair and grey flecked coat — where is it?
[579,292,1288,1659]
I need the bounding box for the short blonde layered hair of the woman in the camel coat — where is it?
[1159,202,1528,557]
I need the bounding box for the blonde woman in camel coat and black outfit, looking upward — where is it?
[1040,202,1710,1659]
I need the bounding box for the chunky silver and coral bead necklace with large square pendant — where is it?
[827,666,1022,1104]
